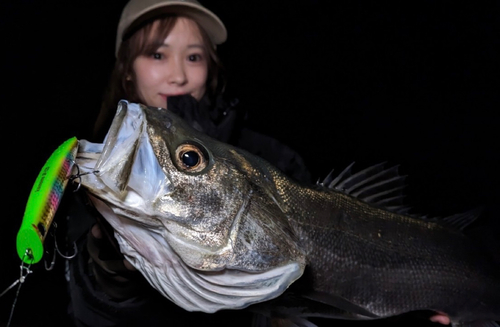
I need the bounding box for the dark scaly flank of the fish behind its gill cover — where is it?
[282,183,499,317]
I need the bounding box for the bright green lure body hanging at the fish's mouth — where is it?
[16,137,78,264]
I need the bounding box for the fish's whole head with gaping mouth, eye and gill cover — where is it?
[77,101,305,312]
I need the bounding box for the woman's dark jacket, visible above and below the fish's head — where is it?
[64,96,311,327]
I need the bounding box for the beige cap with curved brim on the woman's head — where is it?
[115,0,227,55]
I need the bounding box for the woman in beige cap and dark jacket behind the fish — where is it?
[64,0,310,326]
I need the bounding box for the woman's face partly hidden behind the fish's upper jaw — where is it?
[132,17,208,108]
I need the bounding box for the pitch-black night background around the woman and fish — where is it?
[0,0,500,326]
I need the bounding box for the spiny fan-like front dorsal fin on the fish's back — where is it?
[317,162,410,214]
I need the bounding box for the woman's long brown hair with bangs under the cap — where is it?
[92,14,226,142]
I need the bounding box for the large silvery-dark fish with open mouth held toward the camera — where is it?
[76,101,500,326]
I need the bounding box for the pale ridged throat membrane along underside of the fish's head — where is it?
[90,196,302,313]
